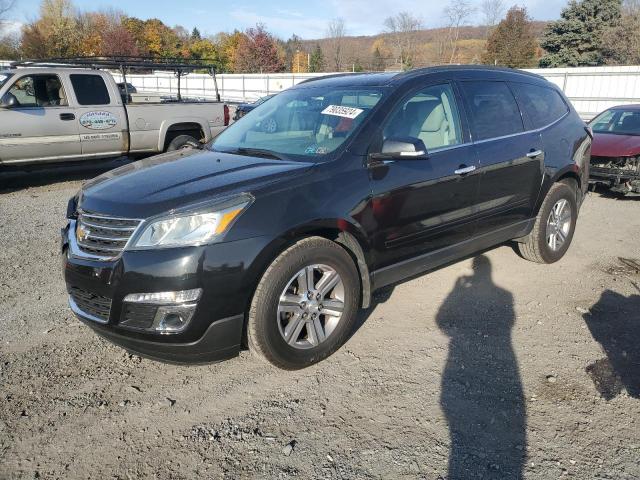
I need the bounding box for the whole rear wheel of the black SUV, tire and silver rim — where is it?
[518,181,578,263]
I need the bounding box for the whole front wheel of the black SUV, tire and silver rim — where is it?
[247,237,360,370]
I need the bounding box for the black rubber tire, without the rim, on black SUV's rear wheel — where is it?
[516,179,578,264]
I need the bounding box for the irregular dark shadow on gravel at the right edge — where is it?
[583,288,640,400]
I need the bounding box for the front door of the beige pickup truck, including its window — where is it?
[0,73,81,163]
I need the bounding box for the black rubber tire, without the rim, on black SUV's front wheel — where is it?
[247,237,361,370]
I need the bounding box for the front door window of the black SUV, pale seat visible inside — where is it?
[383,84,462,150]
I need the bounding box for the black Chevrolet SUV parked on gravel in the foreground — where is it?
[63,67,591,369]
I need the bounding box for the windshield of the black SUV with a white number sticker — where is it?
[210,87,383,159]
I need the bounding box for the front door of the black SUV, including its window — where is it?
[370,83,478,268]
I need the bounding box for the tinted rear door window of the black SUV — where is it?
[460,82,524,140]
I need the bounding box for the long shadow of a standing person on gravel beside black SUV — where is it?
[436,255,527,480]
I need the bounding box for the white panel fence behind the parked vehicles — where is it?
[5,61,640,120]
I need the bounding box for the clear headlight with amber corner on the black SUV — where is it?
[132,197,251,248]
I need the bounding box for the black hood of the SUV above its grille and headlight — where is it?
[79,150,314,218]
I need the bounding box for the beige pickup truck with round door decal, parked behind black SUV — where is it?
[0,62,229,168]
